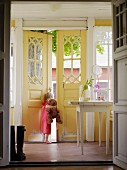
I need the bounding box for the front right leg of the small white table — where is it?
[106,110,110,154]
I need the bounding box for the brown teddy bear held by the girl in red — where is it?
[46,98,62,124]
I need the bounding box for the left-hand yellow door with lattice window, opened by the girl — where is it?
[22,31,52,141]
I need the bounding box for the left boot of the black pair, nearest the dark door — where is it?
[10,126,17,161]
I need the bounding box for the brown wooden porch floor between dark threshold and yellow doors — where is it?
[18,142,112,162]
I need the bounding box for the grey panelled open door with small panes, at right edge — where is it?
[112,0,127,169]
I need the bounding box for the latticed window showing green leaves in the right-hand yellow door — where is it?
[63,36,81,84]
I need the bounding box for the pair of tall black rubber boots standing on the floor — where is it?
[10,126,26,161]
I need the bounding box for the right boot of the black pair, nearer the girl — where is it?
[17,126,26,161]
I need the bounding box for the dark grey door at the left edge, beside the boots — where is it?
[0,0,10,166]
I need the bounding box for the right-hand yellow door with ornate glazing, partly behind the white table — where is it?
[57,30,86,141]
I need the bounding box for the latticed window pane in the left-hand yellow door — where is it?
[28,36,44,85]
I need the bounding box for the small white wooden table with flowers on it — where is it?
[69,100,113,155]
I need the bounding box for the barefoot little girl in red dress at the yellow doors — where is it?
[41,89,53,144]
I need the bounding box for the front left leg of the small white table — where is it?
[80,106,84,155]
